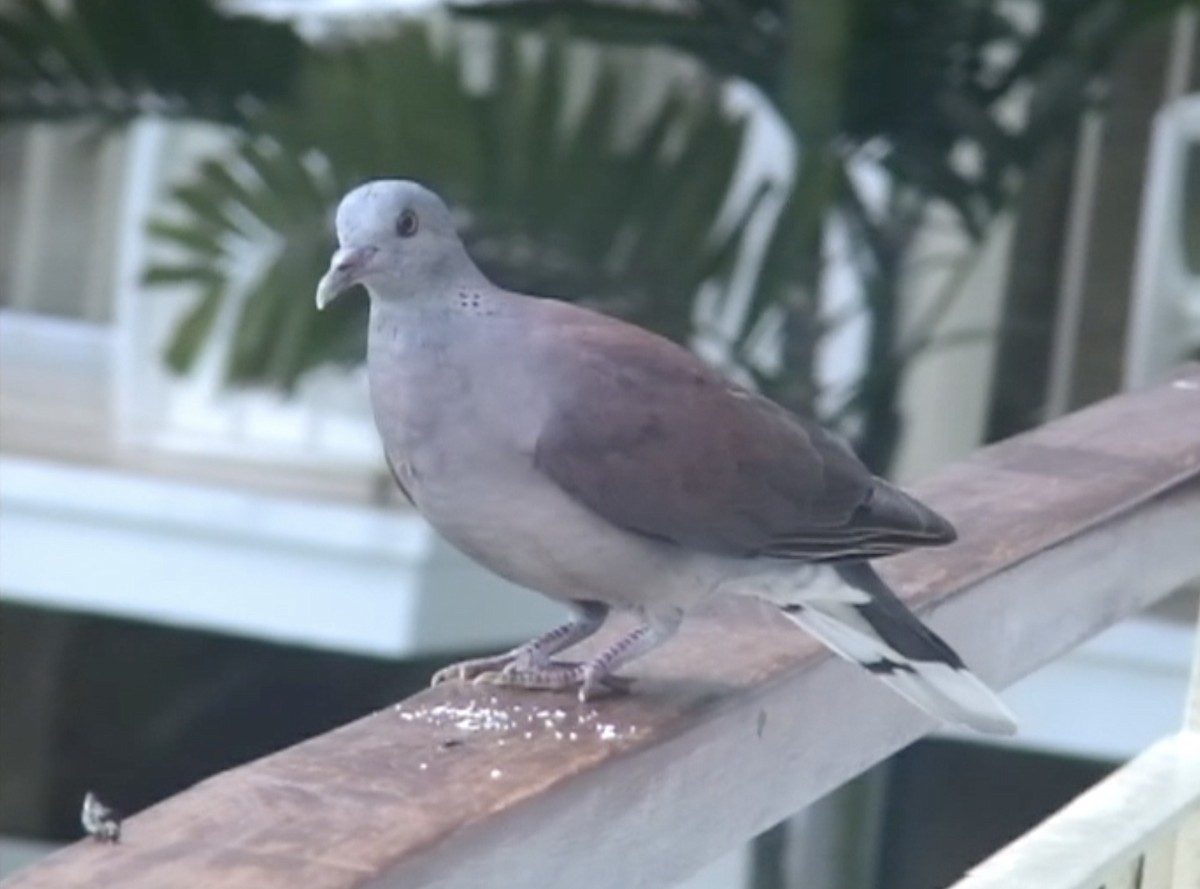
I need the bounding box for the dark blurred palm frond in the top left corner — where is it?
[0,0,302,124]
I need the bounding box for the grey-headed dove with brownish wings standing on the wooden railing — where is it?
[317,180,1016,733]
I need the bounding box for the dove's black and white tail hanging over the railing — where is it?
[782,561,1016,734]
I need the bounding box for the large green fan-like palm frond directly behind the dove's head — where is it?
[146,22,746,386]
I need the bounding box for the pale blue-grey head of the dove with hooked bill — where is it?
[317,179,480,308]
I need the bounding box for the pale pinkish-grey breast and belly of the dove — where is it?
[370,298,725,607]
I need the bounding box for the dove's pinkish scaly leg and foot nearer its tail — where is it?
[490,609,683,701]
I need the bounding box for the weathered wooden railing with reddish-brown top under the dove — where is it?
[11,367,1200,889]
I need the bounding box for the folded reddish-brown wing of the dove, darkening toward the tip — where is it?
[535,310,953,560]
